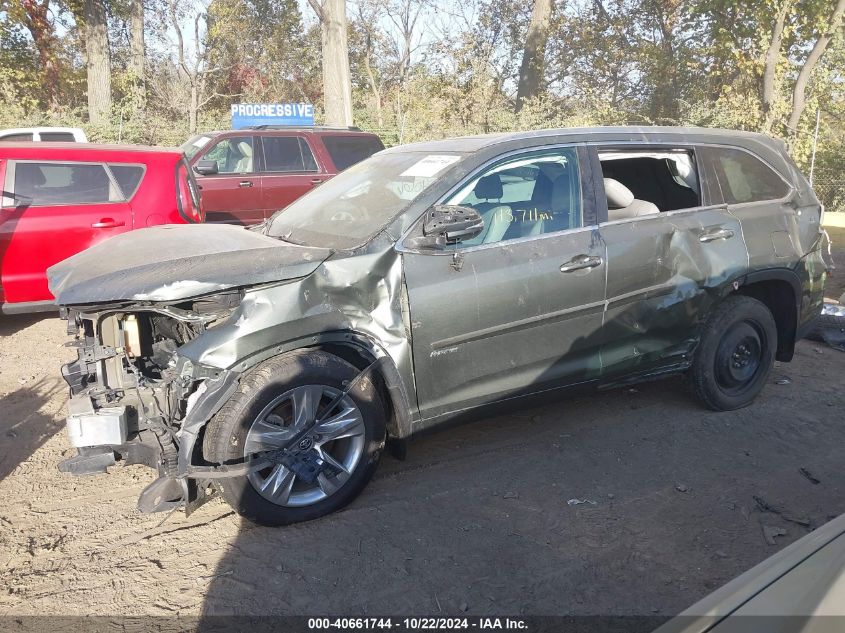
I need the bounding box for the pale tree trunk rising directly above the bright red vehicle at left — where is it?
[82,0,111,124]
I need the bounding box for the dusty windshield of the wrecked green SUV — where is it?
[267,152,461,249]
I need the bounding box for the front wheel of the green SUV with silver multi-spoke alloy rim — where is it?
[203,350,385,525]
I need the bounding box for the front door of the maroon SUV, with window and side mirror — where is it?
[194,134,264,225]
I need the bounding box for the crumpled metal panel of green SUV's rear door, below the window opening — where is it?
[601,207,748,379]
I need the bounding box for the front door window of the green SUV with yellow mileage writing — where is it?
[446,148,581,246]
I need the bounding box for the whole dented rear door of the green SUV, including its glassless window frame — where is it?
[591,145,748,381]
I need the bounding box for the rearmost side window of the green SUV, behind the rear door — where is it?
[708,148,789,204]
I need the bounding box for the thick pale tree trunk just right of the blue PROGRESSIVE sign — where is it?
[320,0,352,127]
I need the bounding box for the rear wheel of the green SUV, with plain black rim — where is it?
[690,295,777,411]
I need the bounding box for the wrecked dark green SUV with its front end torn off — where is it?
[49,127,825,525]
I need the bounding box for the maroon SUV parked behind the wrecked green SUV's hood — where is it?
[182,126,384,224]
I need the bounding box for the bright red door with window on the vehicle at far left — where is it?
[0,161,132,303]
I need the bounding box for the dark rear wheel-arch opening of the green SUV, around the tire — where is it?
[731,268,801,361]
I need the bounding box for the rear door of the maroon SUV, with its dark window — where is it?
[260,134,328,218]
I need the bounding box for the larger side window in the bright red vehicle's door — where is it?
[13,162,123,206]
